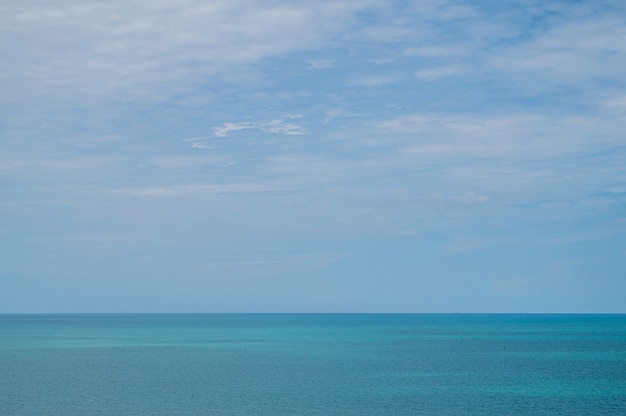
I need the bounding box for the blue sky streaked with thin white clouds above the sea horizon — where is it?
[0,0,626,313]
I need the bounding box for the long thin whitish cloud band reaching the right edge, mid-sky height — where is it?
[375,111,624,157]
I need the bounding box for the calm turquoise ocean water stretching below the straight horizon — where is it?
[0,314,626,416]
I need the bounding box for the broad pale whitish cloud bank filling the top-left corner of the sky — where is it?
[0,0,380,101]
